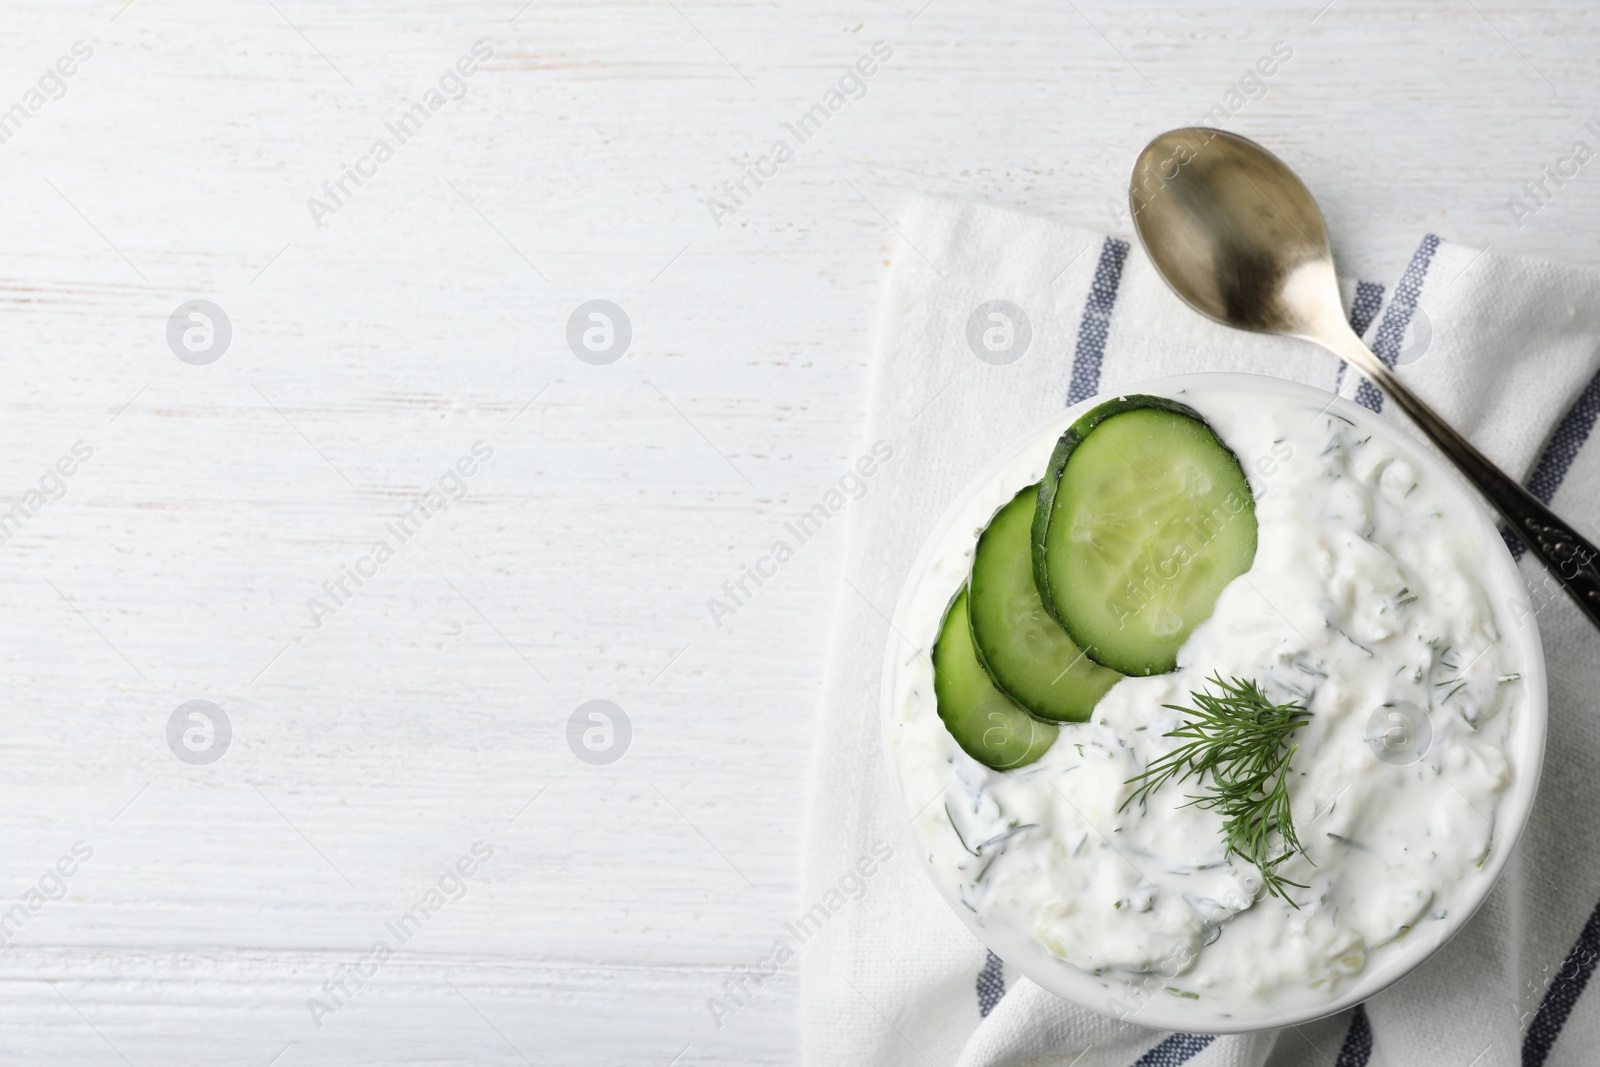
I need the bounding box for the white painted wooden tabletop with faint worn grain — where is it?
[0,0,1600,1067]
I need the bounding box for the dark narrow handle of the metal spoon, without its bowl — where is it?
[1315,333,1600,627]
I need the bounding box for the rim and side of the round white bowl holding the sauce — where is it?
[882,374,1547,1033]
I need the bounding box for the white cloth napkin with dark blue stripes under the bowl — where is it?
[797,198,1600,1067]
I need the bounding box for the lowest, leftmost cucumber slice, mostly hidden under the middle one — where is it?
[933,585,1058,771]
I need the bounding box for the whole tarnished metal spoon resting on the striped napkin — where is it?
[1128,126,1600,625]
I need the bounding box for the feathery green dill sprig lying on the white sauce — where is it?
[1122,675,1310,909]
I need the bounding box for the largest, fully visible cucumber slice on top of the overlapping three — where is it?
[1034,395,1256,675]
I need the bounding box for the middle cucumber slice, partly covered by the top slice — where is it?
[966,485,1122,723]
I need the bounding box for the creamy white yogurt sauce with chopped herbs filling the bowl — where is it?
[890,390,1526,1006]
